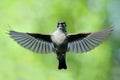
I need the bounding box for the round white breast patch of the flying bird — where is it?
[51,31,66,45]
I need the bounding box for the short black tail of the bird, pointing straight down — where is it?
[57,54,67,69]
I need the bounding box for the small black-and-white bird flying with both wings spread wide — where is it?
[8,21,113,70]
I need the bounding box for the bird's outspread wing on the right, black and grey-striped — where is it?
[68,27,113,53]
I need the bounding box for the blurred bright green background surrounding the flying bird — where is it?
[0,0,120,80]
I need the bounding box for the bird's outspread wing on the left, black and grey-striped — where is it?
[9,31,53,53]
